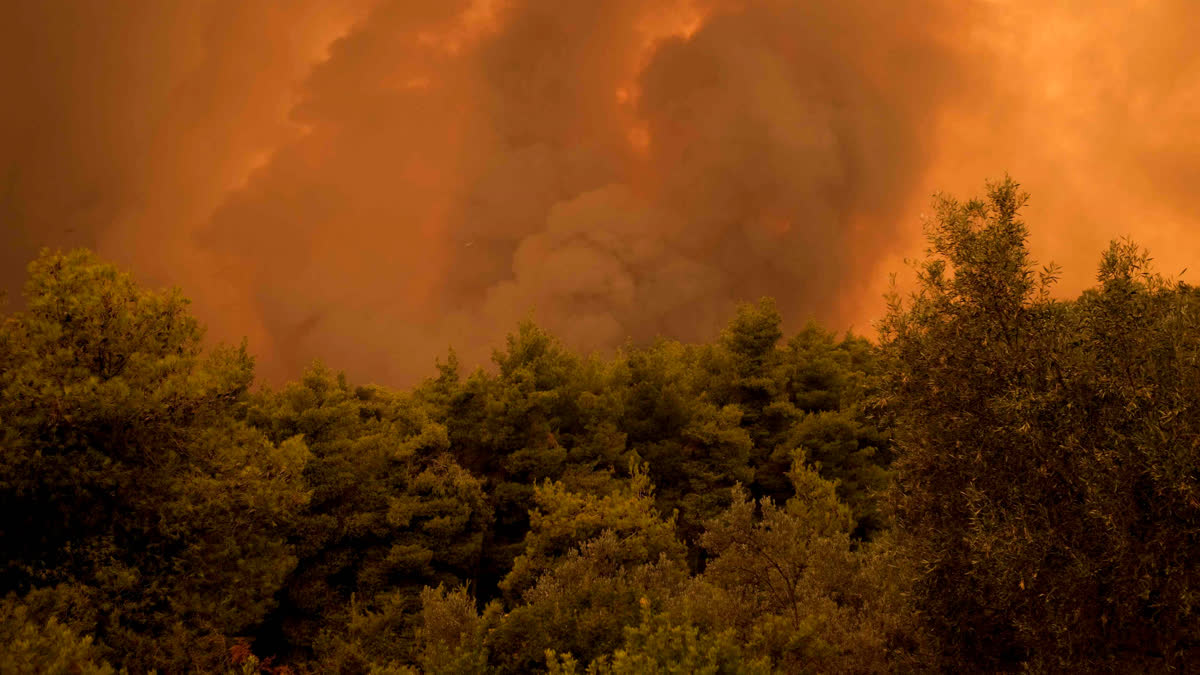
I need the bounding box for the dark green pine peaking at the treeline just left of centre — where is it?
[416,322,629,598]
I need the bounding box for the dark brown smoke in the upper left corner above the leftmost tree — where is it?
[0,0,359,345]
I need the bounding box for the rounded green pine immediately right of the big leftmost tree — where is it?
[247,364,492,670]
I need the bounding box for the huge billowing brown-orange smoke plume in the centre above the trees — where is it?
[199,0,974,380]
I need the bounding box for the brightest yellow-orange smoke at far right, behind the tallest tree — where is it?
[925,0,1200,294]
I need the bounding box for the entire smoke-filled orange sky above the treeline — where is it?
[0,0,1200,384]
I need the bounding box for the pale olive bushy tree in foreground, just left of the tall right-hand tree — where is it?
[673,455,922,673]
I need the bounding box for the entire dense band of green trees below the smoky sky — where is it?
[0,180,1200,675]
